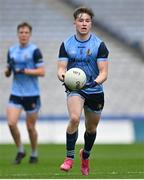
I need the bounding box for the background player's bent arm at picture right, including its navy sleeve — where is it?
[24,49,45,76]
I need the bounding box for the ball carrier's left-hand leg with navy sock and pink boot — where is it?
[60,96,84,171]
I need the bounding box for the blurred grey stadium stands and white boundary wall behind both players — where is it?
[0,0,144,143]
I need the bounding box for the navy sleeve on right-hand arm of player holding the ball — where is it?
[97,42,109,61]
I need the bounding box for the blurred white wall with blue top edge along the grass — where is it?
[0,115,144,143]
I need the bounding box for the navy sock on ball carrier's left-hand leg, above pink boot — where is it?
[66,131,78,159]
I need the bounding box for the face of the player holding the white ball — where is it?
[74,13,92,37]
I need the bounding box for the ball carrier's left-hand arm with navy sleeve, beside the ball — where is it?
[57,43,68,82]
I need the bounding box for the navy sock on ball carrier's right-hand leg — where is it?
[83,132,96,159]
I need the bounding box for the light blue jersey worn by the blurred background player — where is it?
[7,43,44,97]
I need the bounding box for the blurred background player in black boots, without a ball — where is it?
[5,22,45,164]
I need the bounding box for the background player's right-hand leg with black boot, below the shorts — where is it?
[26,112,38,163]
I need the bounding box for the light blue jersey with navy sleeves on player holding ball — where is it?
[59,34,108,94]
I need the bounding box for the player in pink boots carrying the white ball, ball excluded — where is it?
[58,7,109,175]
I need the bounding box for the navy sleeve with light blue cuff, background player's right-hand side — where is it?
[33,48,44,66]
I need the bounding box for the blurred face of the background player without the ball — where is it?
[18,27,31,46]
